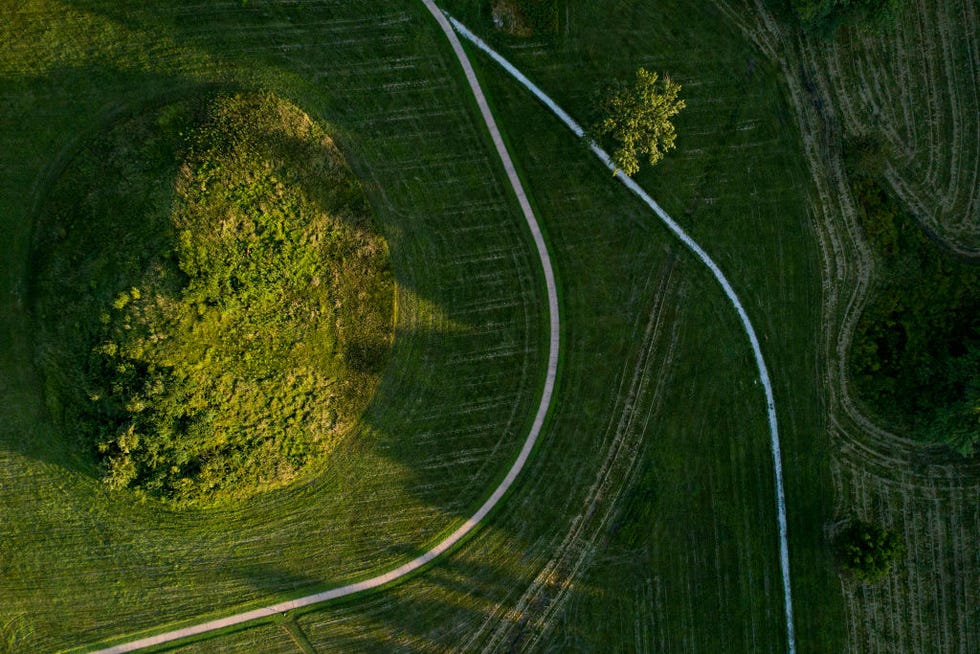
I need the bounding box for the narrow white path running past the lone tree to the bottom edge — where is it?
[442,11,796,654]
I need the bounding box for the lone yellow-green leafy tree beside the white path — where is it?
[589,68,685,176]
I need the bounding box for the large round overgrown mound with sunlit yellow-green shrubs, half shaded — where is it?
[32,93,394,503]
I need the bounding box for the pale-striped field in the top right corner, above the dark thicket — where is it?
[823,0,980,257]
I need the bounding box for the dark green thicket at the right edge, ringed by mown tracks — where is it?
[846,138,980,456]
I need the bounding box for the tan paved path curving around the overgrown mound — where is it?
[96,0,561,654]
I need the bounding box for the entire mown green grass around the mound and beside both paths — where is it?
[0,0,844,652]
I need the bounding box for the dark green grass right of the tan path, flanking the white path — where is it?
[155,3,843,651]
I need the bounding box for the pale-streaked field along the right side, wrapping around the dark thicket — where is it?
[718,0,980,652]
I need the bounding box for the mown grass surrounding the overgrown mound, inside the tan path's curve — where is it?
[0,2,544,651]
